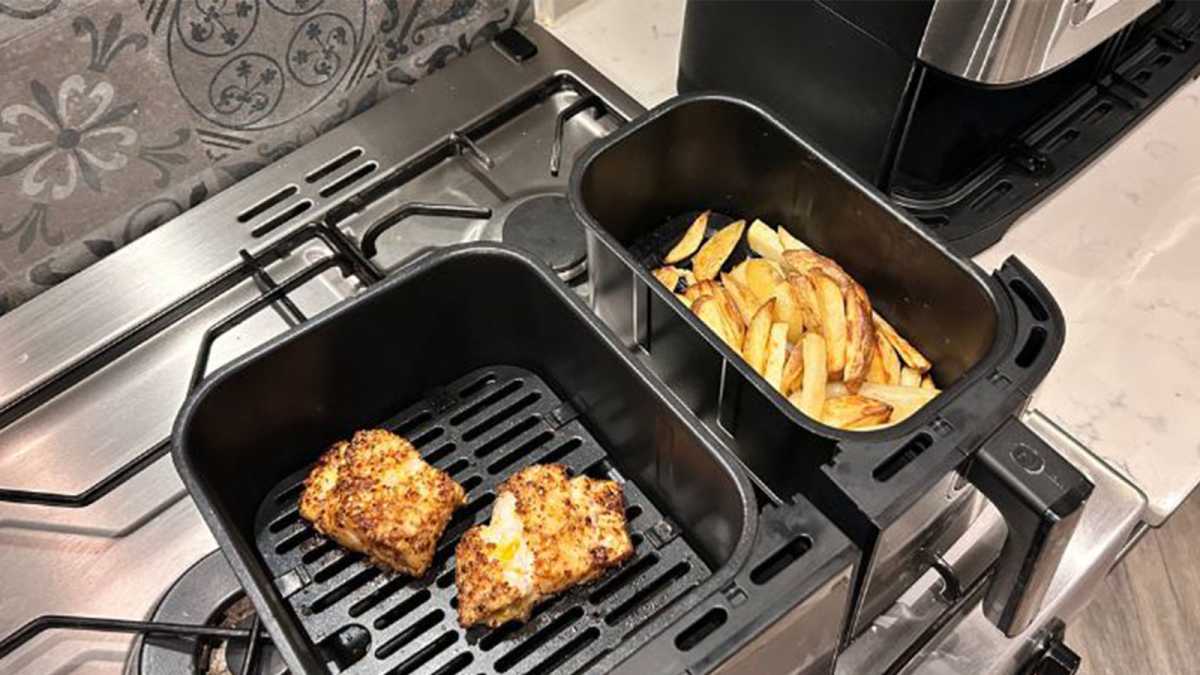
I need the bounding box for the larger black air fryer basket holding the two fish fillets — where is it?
[174,245,857,674]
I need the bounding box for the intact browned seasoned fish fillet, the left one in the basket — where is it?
[300,429,466,577]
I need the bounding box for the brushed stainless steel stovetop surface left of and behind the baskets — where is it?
[0,26,641,675]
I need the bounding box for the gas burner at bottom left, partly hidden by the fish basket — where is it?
[127,551,287,675]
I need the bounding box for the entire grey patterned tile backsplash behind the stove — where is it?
[0,0,532,315]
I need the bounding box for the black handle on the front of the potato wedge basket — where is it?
[967,419,1093,637]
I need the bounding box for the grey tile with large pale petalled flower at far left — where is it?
[0,0,206,278]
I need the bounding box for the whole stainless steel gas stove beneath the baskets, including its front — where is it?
[0,21,1142,675]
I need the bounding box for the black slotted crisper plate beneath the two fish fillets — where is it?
[256,366,710,675]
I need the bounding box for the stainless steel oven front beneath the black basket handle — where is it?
[836,408,1146,675]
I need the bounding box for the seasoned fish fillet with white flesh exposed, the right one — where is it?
[455,464,634,627]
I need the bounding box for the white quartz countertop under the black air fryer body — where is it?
[548,0,1200,525]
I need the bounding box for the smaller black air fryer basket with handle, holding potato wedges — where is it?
[570,94,1091,633]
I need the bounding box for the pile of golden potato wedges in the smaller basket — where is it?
[653,211,938,431]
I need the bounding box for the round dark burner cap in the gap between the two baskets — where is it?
[500,195,587,281]
